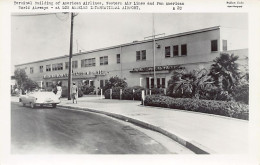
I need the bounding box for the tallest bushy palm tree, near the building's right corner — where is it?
[210,53,240,91]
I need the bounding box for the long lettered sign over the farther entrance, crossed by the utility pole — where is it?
[43,70,107,79]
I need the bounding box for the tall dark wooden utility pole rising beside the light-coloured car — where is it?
[68,13,74,100]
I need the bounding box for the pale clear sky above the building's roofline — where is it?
[11,13,248,73]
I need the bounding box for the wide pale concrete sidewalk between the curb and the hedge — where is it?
[12,96,249,154]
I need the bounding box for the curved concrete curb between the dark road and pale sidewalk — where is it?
[57,105,216,154]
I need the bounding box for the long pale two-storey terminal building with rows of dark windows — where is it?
[15,26,248,88]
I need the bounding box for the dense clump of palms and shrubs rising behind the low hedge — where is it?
[167,53,249,104]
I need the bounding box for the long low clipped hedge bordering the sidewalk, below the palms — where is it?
[144,95,249,120]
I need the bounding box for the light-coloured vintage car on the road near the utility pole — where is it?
[19,91,60,108]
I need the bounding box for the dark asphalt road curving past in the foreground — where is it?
[11,102,184,154]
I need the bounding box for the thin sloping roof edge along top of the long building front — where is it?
[15,26,220,67]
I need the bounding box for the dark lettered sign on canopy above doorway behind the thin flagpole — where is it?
[130,65,185,73]
